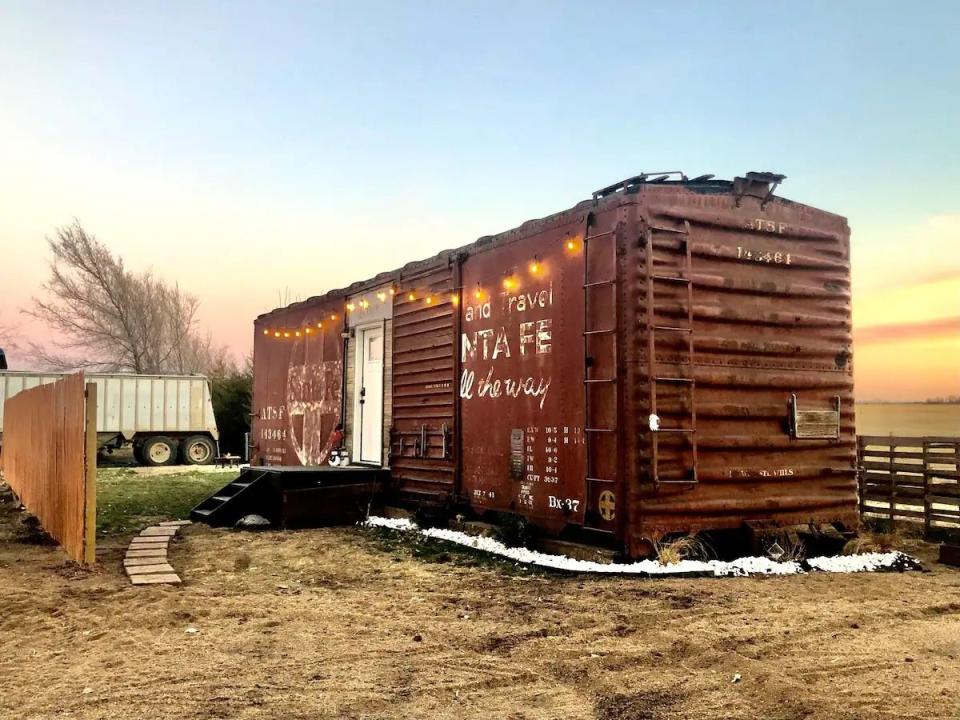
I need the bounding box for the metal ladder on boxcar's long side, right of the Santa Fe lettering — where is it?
[583,225,619,534]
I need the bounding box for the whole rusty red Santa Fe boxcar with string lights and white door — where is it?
[252,173,857,556]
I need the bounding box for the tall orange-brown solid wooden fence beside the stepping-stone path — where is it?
[0,373,97,565]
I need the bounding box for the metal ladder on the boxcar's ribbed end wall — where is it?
[645,221,698,488]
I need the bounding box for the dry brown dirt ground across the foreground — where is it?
[0,500,960,720]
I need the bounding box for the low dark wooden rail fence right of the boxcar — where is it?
[857,435,960,534]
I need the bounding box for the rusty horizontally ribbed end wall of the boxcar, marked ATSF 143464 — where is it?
[624,188,857,550]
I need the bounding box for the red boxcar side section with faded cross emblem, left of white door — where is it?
[251,302,343,465]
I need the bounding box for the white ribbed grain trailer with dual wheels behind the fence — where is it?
[0,370,220,465]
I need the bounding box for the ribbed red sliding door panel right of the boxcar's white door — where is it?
[390,261,456,504]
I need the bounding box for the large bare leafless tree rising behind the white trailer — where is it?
[25,221,224,373]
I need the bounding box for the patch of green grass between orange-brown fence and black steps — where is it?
[97,468,232,537]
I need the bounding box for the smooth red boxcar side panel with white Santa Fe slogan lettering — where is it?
[459,215,584,528]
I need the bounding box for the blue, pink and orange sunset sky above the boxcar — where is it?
[0,0,960,400]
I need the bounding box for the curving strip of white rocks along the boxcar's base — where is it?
[364,516,920,577]
